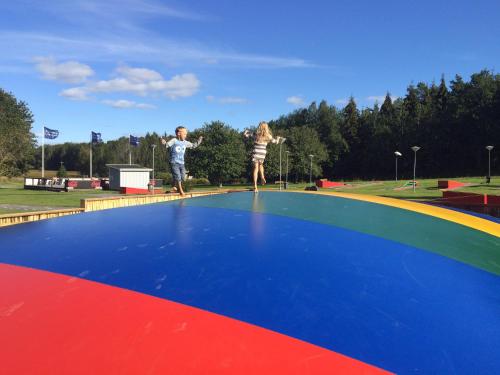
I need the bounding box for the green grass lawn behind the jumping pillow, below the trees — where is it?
[0,176,500,214]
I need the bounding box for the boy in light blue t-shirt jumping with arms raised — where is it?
[160,126,203,195]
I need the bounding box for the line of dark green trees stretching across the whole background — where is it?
[0,70,500,183]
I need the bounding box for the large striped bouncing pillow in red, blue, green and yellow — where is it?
[0,192,500,374]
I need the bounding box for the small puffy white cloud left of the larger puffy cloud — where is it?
[35,57,94,83]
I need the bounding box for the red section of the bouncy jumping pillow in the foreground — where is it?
[0,264,388,375]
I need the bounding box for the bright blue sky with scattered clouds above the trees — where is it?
[0,0,500,143]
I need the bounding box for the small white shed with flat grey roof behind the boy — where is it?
[106,164,152,190]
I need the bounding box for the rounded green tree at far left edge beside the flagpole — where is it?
[0,89,35,177]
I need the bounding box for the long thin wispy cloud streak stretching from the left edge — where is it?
[0,31,316,69]
